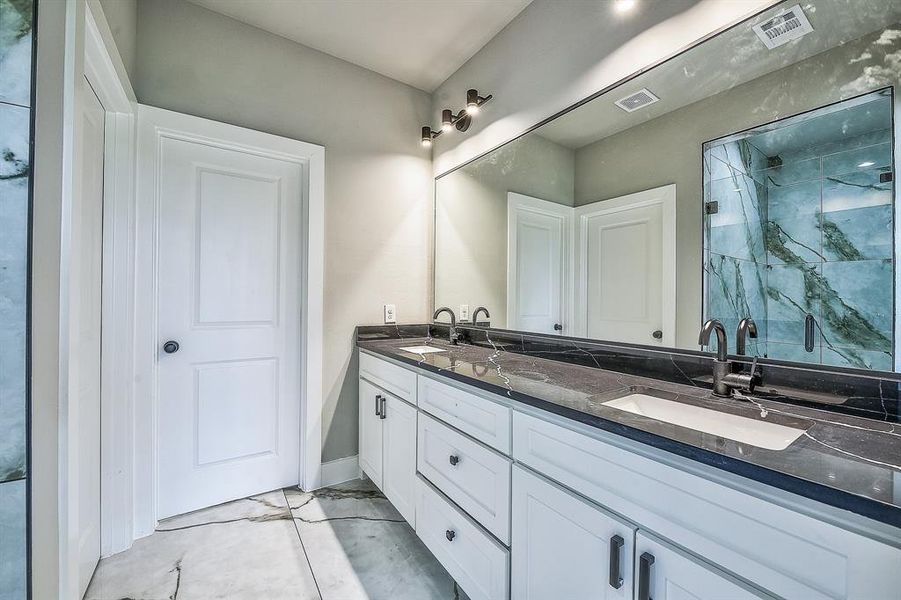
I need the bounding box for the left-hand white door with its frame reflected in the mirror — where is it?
[507,192,572,334]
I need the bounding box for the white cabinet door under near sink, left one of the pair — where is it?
[511,465,636,600]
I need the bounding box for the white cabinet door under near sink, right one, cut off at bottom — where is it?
[634,531,767,600]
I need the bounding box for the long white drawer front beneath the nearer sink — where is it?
[513,412,901,600]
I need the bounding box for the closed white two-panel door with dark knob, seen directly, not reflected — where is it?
[155,112,306,518]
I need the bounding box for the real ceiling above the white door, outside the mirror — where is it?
[189,0,532,93]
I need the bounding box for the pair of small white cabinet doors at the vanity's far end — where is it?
[359,378,416,527]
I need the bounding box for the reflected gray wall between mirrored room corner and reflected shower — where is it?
[575,24,901,348]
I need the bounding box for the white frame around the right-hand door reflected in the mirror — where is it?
[573,183,676,347]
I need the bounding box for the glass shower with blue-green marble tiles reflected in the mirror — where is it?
[703,90,897,370]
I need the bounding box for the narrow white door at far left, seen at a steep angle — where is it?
[69,80,106,597]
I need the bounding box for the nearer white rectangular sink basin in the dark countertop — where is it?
[604,394,804,450]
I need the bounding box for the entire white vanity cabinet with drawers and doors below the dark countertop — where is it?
[360,353,901,600]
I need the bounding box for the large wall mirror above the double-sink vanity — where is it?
[435,0,901,371]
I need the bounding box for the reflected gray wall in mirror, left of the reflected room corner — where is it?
[435,134,575,327]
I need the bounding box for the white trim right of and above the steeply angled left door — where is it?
[84,0,135,556]
